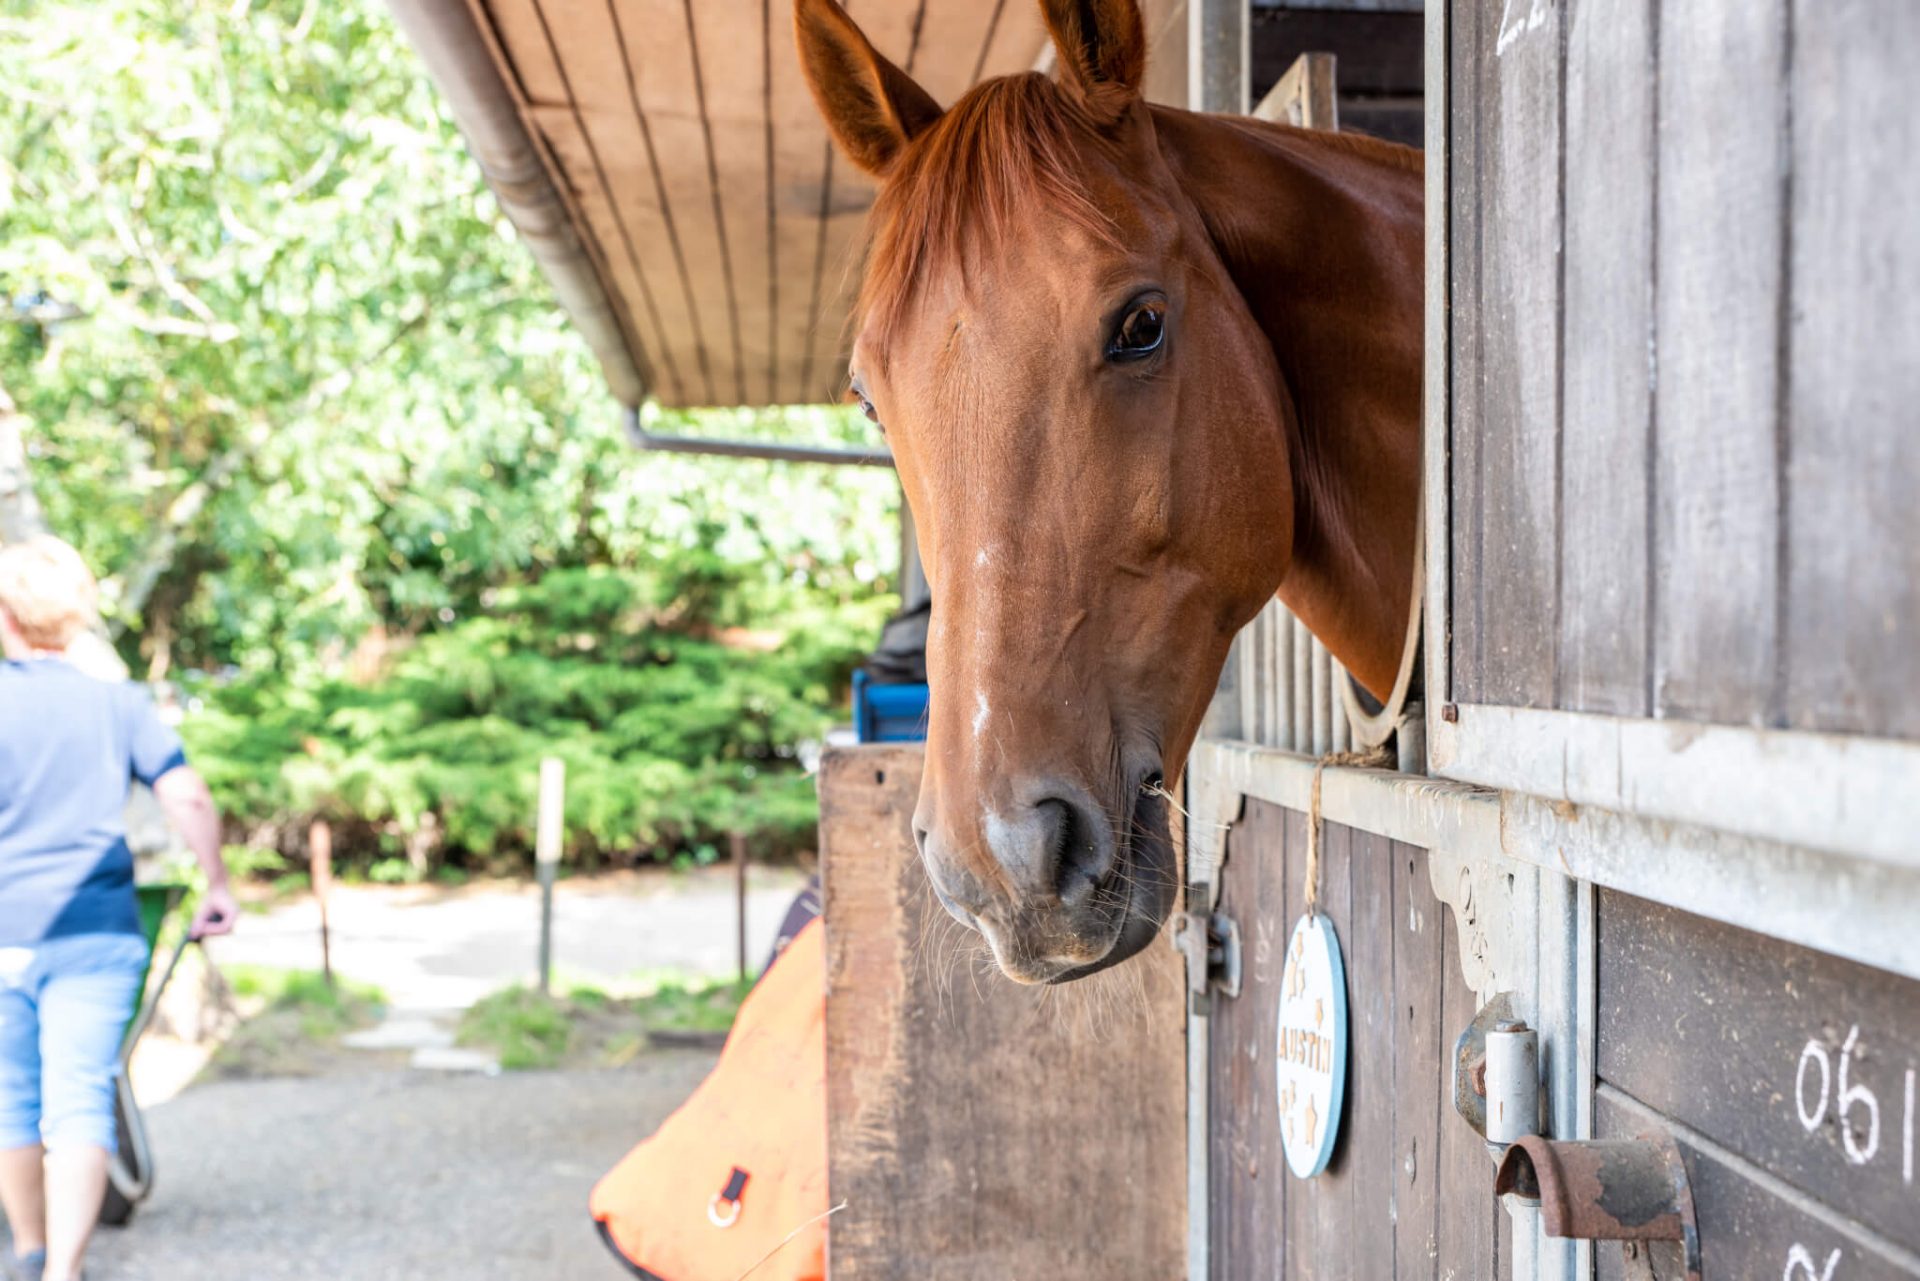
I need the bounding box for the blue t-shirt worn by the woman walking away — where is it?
[0,659,186,947]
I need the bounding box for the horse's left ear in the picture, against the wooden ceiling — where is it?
[793,0,941,177]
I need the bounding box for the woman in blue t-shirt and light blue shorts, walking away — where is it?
[0,538,234,1281]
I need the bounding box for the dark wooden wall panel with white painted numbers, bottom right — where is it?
[1596,891,1920,1281]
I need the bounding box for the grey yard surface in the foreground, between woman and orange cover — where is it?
[86,1051,712,1281]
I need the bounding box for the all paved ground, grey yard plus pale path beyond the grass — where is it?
[24,868,801,1281]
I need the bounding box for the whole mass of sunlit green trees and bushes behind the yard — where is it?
[0,0,899,878]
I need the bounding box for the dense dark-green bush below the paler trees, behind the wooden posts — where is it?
[182,557,889,882]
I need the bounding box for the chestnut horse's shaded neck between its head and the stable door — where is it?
[1154,108,1425,697]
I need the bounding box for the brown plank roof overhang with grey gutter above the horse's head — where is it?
[390,0,1046,407]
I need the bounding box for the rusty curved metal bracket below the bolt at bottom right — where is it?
[1494,1131,1699,1281]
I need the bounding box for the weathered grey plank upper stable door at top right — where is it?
[1450,0,1920,737]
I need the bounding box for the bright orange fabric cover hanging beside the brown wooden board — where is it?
[588,920,828,1281]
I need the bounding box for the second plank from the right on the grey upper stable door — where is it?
[1651,0,1786,724]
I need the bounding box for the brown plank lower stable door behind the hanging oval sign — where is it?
[1205,801,1511,1281]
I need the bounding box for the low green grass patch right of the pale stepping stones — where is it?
[459,974,751,1072]
